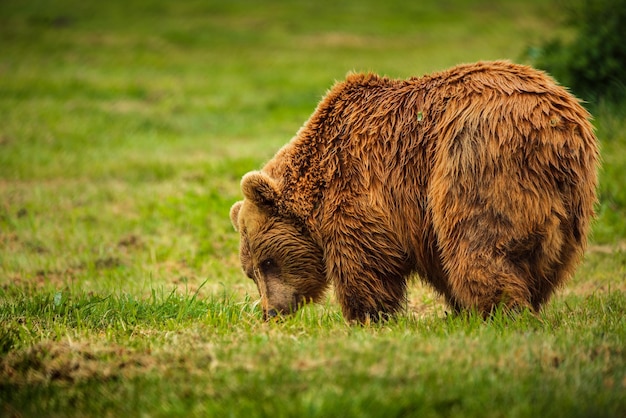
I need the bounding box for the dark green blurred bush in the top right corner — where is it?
[529,0,626,103]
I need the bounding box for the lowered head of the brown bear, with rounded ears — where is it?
[230,171,328,319]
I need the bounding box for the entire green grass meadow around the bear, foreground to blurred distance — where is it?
[0,0,626,417]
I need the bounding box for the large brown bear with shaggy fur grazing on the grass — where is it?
[230,61,599,321]
